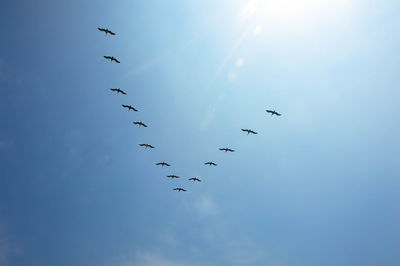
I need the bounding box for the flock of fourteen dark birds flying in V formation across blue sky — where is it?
[97,28,281,191]
